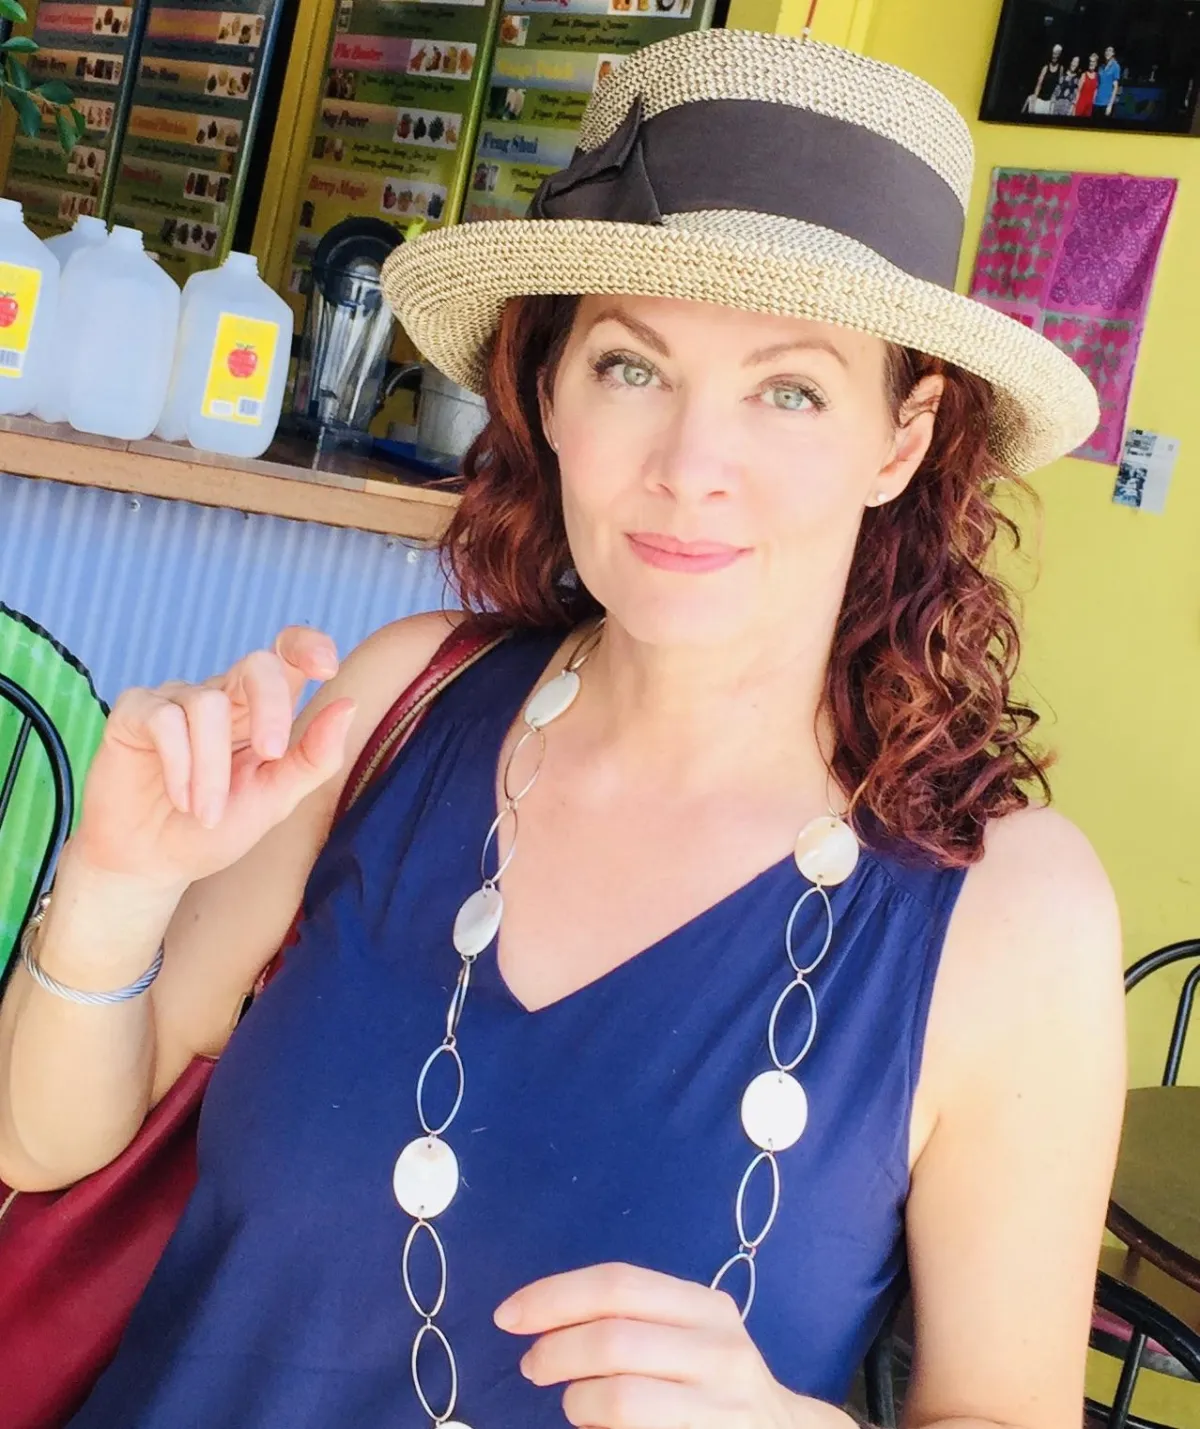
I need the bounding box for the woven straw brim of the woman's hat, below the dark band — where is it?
[383,211,1099,474]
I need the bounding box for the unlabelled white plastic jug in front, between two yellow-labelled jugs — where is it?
[63,227,180,442]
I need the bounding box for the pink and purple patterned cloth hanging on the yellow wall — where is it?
[971,169,1177,462]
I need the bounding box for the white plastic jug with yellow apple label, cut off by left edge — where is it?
[0,199,59,416]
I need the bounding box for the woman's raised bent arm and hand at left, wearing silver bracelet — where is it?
[0,616,462,1190]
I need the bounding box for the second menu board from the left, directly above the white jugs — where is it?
[109,0,286,283]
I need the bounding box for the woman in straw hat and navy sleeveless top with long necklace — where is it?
[0,31,1124,1429]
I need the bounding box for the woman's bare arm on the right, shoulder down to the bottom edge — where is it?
[904,810,1126,1429]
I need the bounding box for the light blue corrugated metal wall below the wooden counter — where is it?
[0,471,446,703]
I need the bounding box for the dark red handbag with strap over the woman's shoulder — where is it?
[0,620,504,1429]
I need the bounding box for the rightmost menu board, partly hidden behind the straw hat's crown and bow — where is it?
[463,0,713,220]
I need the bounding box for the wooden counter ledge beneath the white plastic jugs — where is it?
[0,417,459,542]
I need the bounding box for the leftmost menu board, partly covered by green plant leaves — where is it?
[4,0,136,237]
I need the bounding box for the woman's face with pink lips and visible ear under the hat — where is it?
[543,297,941,644]
